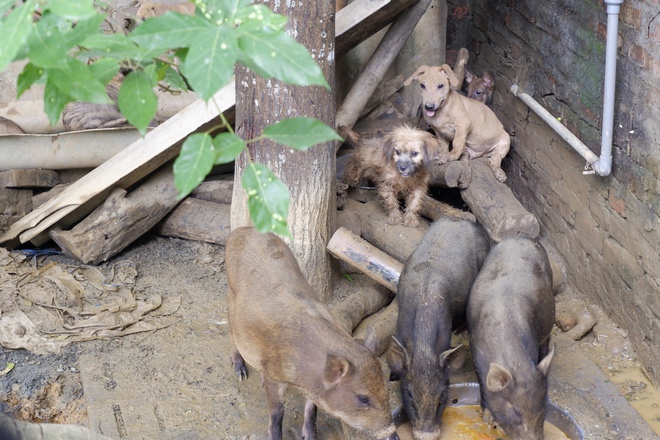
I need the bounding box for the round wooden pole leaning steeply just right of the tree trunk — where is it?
[335,0,431,141]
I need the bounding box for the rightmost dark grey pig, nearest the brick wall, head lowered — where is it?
[467,237,555,440]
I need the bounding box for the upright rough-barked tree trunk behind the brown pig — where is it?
[231,0,336,301]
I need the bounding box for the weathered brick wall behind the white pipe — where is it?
[447,0,660,380]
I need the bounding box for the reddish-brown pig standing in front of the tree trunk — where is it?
[225,227,398,440]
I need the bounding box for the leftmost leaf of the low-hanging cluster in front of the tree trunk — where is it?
[174,133,215,200]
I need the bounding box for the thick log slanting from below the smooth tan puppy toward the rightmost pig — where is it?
[461,157,541,241]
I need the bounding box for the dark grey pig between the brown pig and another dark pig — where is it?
[387,217,490,440]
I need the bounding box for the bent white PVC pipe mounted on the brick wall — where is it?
[511,0,623,176]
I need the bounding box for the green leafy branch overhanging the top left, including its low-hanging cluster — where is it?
[0,0,340,235]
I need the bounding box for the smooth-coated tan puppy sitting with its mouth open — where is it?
[404,64,511,182]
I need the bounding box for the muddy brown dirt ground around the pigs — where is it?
[0,230,660,440]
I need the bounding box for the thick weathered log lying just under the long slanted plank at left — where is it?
[50,164,179,264]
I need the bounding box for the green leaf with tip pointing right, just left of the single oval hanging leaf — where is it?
[48,59,112,104]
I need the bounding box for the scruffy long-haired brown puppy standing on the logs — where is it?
[339,125,447,227]
